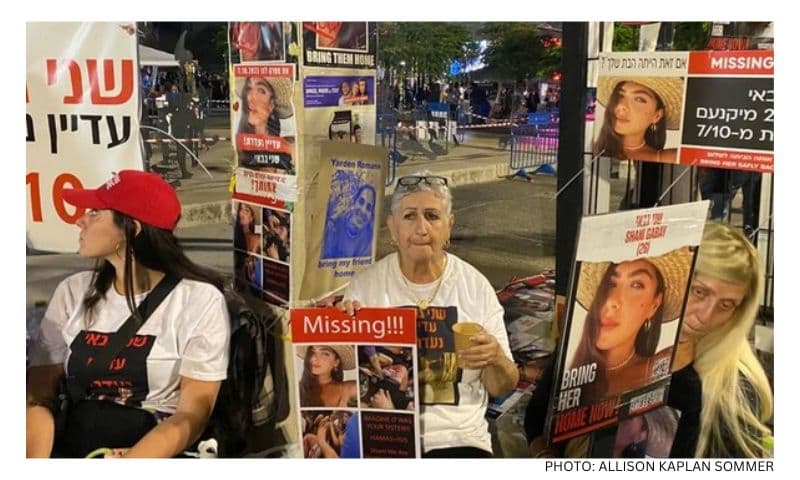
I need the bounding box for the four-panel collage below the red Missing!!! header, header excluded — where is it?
[294,344,417,458]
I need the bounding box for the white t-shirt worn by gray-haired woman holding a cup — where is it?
[344,253,511,452]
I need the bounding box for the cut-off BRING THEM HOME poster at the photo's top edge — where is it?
[303,22,377,69]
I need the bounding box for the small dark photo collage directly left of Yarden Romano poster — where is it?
[233,201,291,306]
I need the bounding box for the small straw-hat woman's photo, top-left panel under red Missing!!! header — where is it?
[297,345,358,407]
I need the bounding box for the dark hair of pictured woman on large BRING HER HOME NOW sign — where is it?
[572,262,666,398]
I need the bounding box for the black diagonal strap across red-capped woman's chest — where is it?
[67,275,180,401]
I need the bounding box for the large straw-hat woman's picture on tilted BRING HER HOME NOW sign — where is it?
[572,247,692,404]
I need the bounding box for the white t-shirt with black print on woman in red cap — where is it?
[31,272,230,414]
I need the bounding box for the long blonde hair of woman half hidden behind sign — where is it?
[694,223,772,458]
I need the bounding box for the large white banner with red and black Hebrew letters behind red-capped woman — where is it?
[25,22,143,252]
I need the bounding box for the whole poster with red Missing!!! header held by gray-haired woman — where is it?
[290,308,421,458]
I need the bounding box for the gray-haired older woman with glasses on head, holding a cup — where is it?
[339,171,519,458]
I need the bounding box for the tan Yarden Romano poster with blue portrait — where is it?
[299,142,386,300]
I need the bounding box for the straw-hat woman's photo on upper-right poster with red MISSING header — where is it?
[594,77,683,163]
